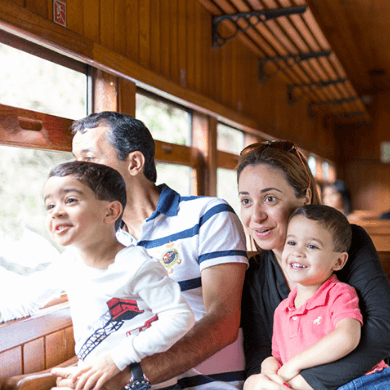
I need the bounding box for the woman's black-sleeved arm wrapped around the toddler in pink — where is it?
[301,225,390,390]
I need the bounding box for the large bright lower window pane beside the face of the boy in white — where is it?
[0,145,73,283]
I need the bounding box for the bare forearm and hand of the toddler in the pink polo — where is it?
[278,318,361,382]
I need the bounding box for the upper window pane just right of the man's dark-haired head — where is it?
[135,92,191,146]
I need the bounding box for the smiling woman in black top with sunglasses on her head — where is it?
[237,141,390,390]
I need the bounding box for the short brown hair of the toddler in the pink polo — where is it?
[289,204,352,252]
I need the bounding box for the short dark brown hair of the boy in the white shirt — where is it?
[49,161,126,230]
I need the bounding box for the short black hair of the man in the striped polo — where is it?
[71,111,157,183]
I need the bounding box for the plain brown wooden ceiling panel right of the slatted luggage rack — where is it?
[306,0,390,96]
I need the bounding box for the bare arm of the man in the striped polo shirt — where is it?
[141,263,247,383]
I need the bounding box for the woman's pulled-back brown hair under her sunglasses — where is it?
[237,141,320,204]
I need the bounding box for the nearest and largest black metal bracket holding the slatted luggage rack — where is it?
[213,5,306,49]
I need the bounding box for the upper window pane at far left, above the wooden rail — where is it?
[0,43,87,119]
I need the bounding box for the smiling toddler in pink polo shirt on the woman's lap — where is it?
[261,205,387,386]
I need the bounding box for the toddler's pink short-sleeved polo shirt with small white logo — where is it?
[272,275,363,363]
